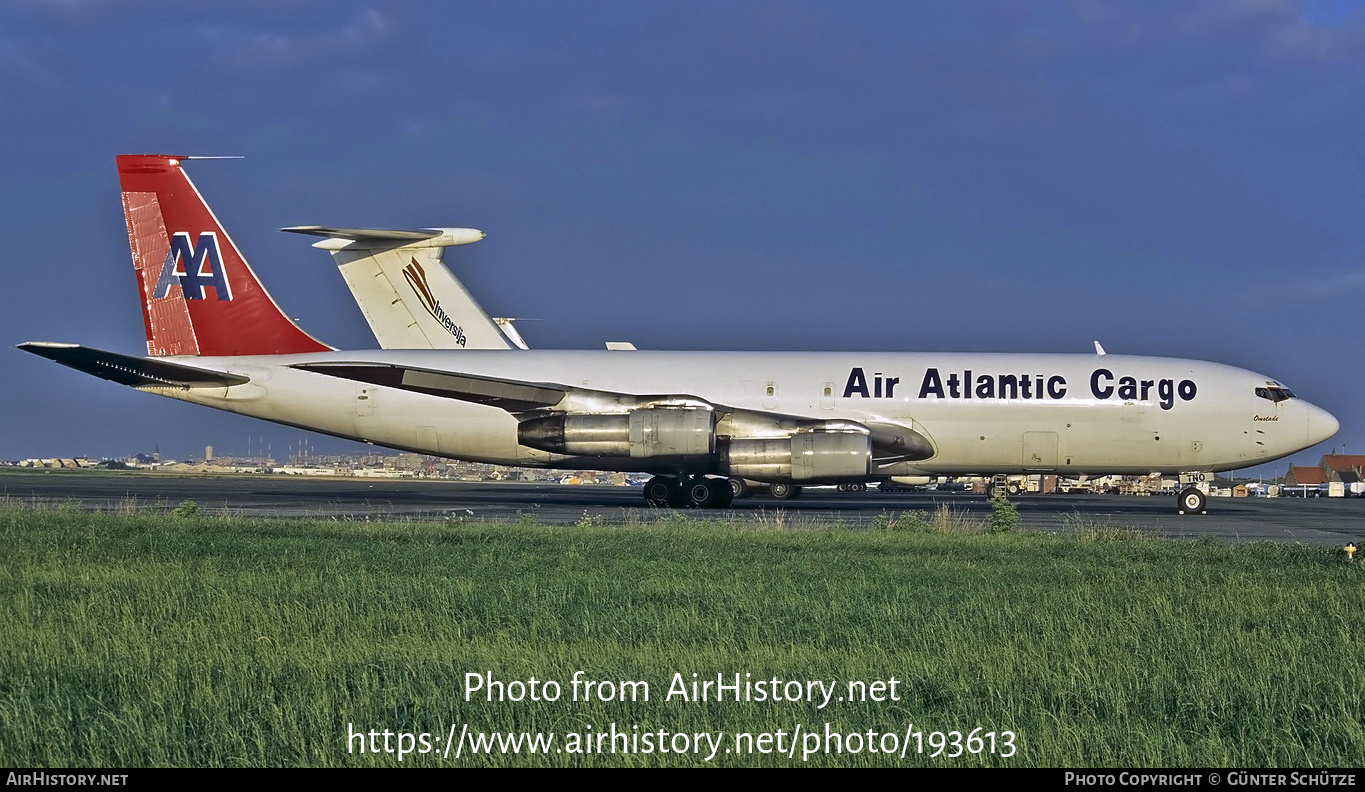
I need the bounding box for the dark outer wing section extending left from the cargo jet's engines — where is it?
[293,363,569,412]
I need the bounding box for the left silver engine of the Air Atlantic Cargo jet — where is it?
[516,407,715,459]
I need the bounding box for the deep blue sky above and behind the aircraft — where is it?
[0,0,1365,472]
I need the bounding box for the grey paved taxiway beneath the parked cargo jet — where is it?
[0,471,1365,545]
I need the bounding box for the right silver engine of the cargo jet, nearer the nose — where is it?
[719,432,872,481]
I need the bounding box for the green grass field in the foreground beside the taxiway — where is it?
[0,508,1365,766]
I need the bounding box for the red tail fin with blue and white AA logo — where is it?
[117,156,330,356]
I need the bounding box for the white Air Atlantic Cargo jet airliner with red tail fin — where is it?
[19,156,1338,512]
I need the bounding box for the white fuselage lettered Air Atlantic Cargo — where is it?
[146,350,1338,475]
